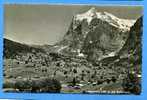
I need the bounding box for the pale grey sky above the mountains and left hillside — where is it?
[4,4,143,45]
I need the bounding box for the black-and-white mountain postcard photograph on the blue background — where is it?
[3,4,143,95]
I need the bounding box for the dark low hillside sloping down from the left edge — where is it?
[4,38,45,58]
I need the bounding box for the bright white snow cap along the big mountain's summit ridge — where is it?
[74,7,135,30]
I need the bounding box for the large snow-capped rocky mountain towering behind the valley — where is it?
[54,8,135,60]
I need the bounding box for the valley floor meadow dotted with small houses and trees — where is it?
[4,51,127,93]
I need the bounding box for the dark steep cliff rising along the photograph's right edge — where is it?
[119,17,143,55]
